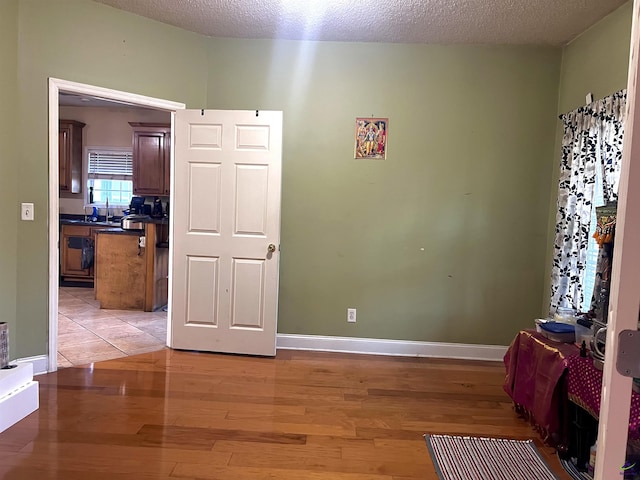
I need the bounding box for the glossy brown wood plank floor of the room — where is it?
[0,349,569,480]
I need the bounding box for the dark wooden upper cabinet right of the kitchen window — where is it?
[129,122,171,195]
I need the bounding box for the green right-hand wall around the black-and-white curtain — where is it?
[542,1,633,315]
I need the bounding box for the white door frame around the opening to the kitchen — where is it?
[47,77,186,372]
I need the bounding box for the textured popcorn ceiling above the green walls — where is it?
[95,0,627,45]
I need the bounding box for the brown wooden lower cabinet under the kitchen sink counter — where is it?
[60,225,97,282]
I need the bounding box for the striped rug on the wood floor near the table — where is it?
[424,435,558,480]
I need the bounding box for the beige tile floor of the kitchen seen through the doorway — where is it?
[58,287,167,368]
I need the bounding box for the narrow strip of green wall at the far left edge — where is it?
[0,0,19,359]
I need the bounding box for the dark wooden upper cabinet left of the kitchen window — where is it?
[58,120,85,193]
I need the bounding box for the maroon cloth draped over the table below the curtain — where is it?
[503,330,640,451]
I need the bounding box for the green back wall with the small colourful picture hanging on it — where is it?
[208,39,560,345]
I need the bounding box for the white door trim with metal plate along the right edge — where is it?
[594,0,640,480]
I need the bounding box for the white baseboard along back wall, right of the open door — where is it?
[276,333,509,361]
